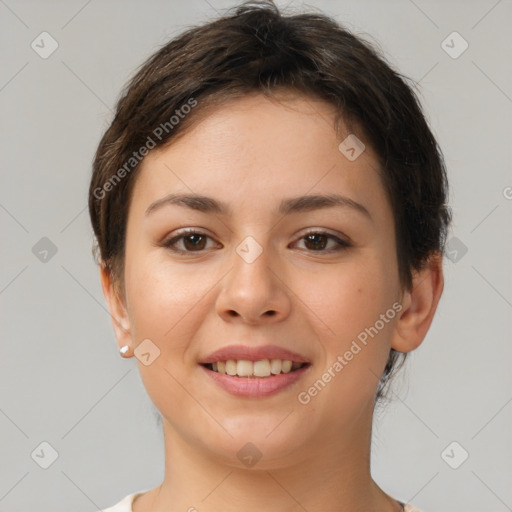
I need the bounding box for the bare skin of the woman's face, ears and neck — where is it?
[101,93,443,512]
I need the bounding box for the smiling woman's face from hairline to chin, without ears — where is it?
[111,94,401,467]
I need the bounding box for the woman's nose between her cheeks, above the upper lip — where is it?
[216,239,291,325]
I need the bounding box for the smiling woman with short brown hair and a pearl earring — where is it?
[89,1,450,512]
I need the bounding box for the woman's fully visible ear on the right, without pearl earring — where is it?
[391,252,444,352]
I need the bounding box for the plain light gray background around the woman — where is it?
[0,0,512,512]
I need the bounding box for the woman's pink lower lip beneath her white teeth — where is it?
[199,364,311,398]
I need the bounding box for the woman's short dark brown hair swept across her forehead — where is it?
[89,0,451,398]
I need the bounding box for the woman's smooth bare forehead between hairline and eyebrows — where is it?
[133,94,390,222]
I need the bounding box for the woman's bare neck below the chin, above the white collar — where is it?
[133,404,401,512]
